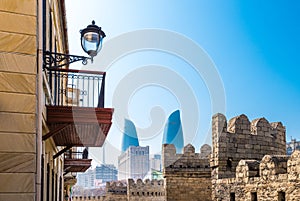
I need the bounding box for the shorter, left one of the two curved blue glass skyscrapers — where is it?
[122,119,139,152]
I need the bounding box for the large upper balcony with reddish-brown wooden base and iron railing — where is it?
[43,68,113,148]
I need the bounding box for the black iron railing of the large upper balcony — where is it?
[46,68,105,108]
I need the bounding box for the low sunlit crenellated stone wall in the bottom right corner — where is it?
[212,151,300,200]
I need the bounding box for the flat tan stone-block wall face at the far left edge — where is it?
[0,0,42,201]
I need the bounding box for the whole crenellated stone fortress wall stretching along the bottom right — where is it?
[73,114,300,201]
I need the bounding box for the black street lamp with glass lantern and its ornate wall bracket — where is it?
[43,20,106,68]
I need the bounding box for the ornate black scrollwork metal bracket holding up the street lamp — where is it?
[43,51,93,68]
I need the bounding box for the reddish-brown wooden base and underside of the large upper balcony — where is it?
[47,106,113,147]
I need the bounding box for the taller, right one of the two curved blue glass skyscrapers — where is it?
[162,110,184,153]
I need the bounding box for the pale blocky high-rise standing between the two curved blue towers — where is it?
[118,146,150,180]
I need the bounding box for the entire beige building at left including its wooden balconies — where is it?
[0,0,113,201]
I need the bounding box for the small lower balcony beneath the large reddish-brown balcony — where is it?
[64,150,92,173]
